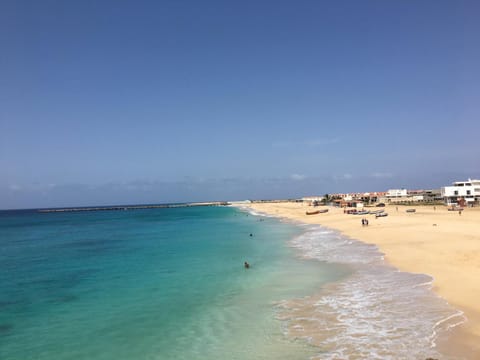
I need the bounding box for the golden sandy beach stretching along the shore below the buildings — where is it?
[242,202,480,359]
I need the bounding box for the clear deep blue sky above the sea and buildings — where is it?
[0,0,480,209]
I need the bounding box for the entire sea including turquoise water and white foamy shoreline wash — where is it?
[0,207,463,360]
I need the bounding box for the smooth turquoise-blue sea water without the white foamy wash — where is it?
[0,207,346,360]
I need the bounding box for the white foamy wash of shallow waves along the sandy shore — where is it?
[278,226,466,359]
